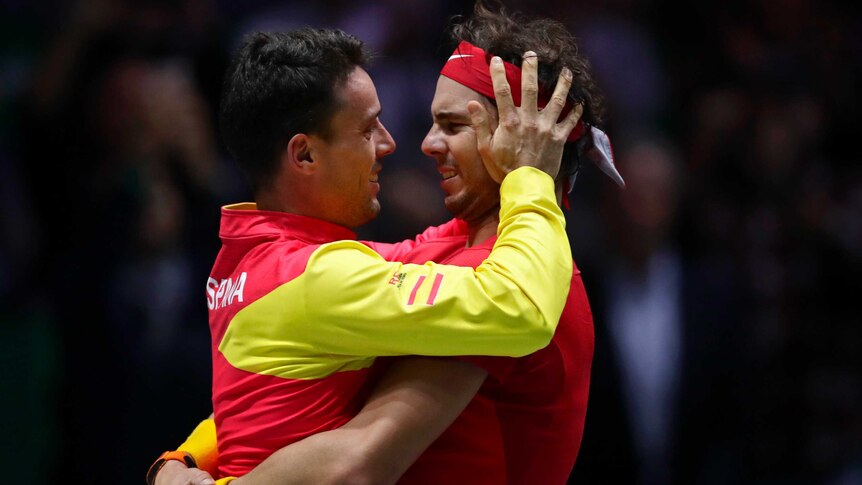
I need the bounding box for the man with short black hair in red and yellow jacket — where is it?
[149,18,581,479]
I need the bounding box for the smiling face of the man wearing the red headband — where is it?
[422,76,500,226]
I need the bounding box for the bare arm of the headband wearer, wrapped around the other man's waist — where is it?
[155,357,487,485]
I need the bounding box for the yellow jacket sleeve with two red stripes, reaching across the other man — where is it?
[219,168,572,364]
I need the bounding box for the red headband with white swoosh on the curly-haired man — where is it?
[440,41,586,142]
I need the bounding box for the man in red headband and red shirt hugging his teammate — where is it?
[148,4,622,484]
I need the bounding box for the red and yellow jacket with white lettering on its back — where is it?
[207,168,572,476]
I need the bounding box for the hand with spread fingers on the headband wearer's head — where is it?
[467,51,583,183]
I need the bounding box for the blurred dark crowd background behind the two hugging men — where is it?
[0,0,862,485]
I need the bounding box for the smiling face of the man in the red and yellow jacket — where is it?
[310,67,395,228]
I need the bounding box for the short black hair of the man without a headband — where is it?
[219,28,370,194]
